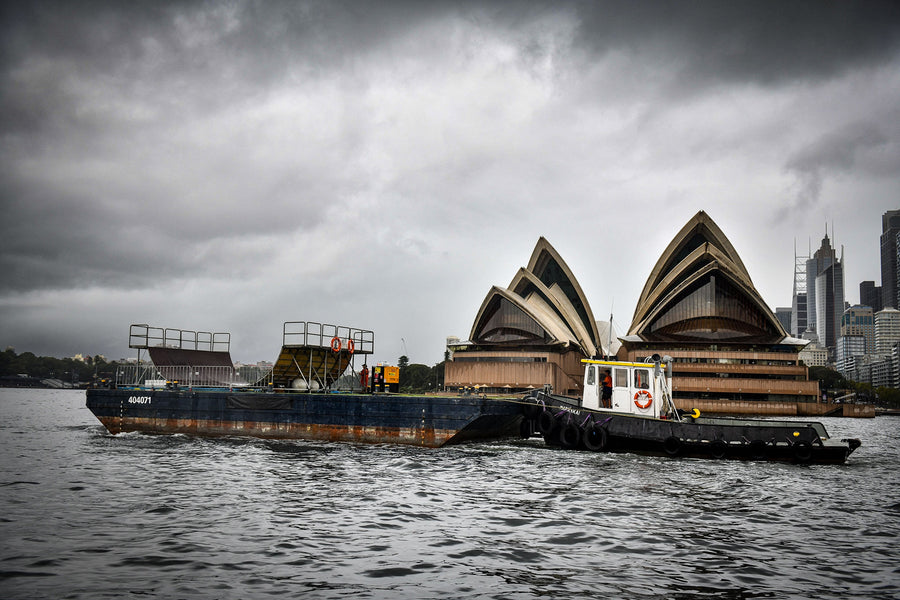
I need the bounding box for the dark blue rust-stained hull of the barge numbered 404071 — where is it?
[87,388,523,447]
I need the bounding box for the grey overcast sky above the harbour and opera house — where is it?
[0,0,900,364]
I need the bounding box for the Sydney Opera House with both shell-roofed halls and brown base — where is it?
[444,211,819,412]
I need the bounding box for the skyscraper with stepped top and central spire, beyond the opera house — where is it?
[806,233,844,351]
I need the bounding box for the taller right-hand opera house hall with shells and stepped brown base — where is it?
[619,211,819,413]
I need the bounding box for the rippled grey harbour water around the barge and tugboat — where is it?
[0,389,900,599]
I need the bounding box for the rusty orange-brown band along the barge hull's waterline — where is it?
[99,416,456,448]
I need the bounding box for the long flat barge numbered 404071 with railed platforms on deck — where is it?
[86,321,524,447]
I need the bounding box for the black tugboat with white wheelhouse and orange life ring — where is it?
[523,354,860,464]
